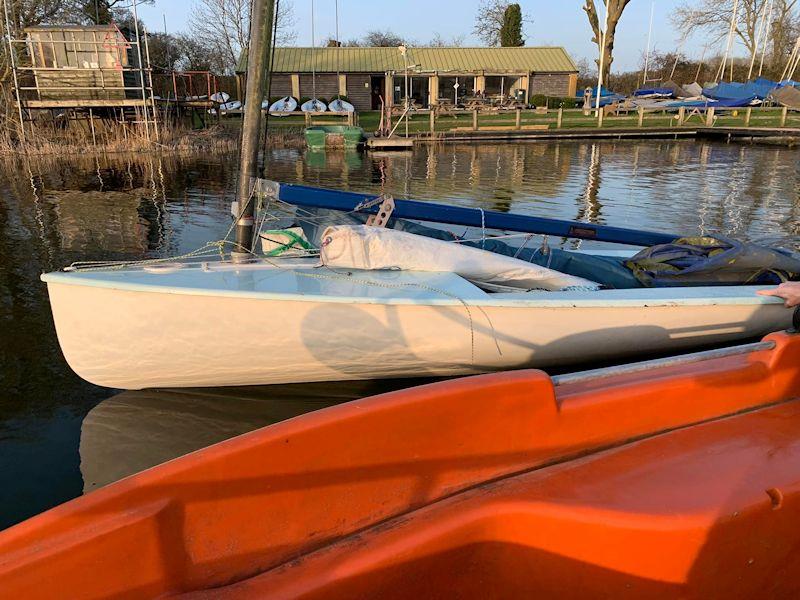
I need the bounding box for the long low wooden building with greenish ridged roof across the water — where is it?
[237,47,578,110]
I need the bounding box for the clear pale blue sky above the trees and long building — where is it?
[134,0,736,71]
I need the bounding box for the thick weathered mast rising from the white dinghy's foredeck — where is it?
[236,0,275,253]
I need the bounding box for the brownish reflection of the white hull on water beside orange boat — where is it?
[80,379,438,493]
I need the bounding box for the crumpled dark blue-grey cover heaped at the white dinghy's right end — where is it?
[625,236,800,287]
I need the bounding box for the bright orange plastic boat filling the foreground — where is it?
[0,333,800,599]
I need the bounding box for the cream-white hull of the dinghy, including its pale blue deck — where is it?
[44,265,791,389]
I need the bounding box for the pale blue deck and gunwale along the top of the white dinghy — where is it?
[42,259,780,307]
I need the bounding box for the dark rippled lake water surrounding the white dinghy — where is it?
[0,142,800,528]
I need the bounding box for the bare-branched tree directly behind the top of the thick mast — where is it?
[189,0,297,73]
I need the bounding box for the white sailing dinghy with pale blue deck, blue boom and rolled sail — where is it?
[42,183,791,389]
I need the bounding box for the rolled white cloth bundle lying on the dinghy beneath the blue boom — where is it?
[320,225,600,291]
